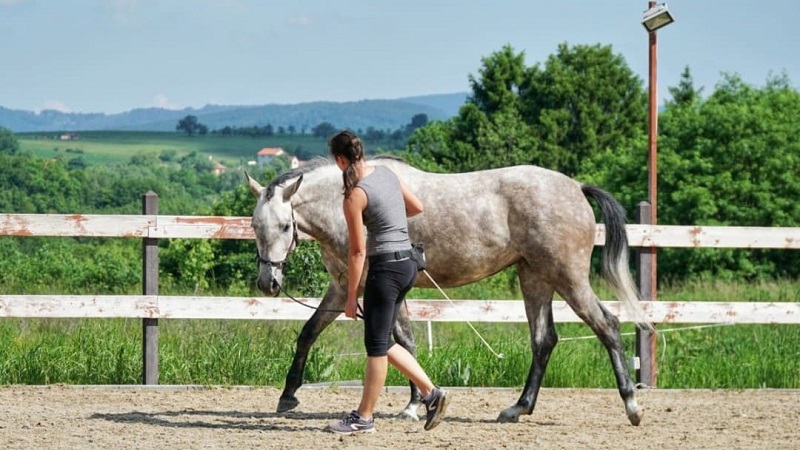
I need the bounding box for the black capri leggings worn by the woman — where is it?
[364,258,417,356]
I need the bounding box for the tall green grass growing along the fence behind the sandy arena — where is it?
[0,279,800,389]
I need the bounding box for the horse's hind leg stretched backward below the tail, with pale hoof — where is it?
[561,280,644,425]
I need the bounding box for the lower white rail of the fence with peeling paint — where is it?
[0,295,800,324]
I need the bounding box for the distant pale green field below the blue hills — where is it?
[16,131,327,166]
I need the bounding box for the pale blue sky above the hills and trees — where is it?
[0,0,800,113]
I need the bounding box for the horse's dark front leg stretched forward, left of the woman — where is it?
[278,283,345,412]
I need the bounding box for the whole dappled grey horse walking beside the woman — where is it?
[245,158,648,425]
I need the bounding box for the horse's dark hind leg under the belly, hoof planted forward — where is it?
[497,262,558,422]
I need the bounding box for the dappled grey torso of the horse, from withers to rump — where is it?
[372,161,595,285]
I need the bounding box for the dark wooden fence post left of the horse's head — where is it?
[142,191,158,384]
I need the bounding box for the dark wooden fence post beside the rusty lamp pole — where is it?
[636,202,658,387]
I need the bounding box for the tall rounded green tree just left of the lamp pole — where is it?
[520,44,647,176]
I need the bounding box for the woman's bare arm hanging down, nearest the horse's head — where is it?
[342,188,367,319]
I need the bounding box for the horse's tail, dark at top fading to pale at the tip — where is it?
[581,184,653,329]
